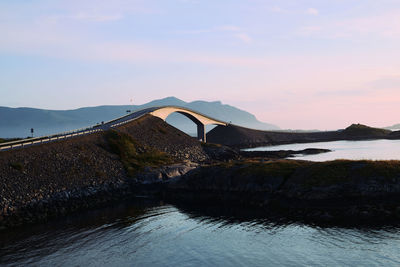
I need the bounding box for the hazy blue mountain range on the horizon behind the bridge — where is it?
[0,97,279,138]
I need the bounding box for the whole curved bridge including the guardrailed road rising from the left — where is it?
[0,106,227,151]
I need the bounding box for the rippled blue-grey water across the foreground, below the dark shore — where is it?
[0,200,400,266]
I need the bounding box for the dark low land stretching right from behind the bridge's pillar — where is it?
[207,124,400,148]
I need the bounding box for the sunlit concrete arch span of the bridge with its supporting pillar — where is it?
[150,106,227,142]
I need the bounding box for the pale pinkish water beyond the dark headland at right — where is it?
[246,140,400,161]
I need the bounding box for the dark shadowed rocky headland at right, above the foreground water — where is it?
[164,160,400,224]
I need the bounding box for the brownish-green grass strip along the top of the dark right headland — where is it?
[218,160,400,187]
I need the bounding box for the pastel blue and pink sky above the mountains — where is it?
[0,0,400,130]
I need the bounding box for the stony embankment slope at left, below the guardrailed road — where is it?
[0,115,234,228]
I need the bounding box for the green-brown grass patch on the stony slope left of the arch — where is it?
[105,130,173,176]
